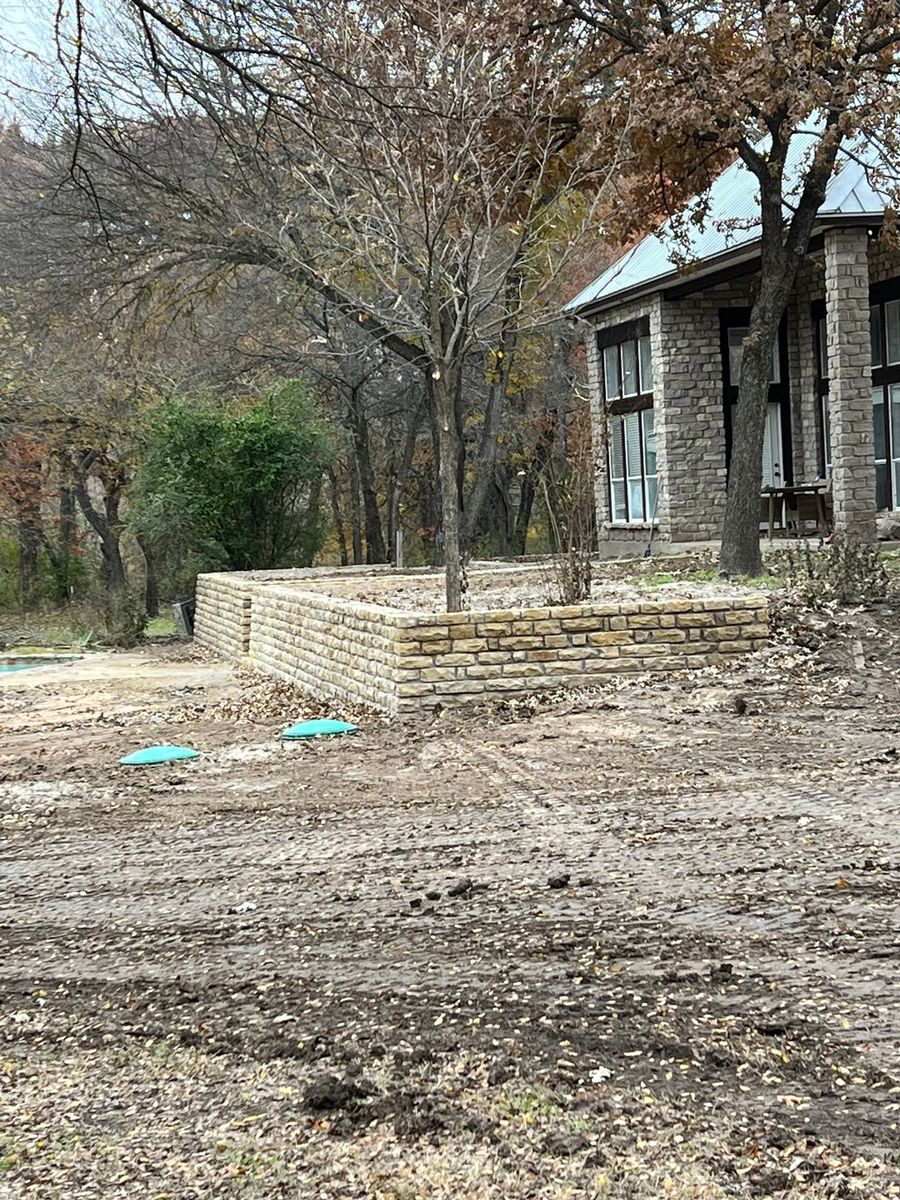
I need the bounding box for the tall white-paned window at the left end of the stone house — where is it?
[600,319,658,524]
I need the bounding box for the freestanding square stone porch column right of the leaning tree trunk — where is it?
[824,227,875,541]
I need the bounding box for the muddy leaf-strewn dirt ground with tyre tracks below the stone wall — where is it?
[0,611,900,1200]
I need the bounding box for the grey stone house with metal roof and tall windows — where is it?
[566,138,900,542]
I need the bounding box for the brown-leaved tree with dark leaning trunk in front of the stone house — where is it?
[561,0,900,575]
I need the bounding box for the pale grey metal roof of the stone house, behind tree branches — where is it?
[564,132,890,313]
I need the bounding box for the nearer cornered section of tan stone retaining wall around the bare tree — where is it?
[232,583,768,714]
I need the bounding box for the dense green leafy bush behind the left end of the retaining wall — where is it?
[131,382,330,570]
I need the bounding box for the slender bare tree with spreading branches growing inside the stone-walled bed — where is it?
[26,2,613,608]
